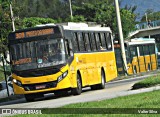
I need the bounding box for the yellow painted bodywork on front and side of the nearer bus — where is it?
[12,51,117,94]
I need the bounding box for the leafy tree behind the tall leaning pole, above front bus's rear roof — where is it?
[73,0,136,37]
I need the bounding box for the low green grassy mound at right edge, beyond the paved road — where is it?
[132,75,160,89]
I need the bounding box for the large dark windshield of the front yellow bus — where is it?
[10,38,66,71]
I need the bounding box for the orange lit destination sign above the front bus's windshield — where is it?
[15,28,54,39]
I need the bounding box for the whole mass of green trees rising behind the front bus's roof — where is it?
[0,0,136,53]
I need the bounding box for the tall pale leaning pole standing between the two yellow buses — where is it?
[114,0,127,72]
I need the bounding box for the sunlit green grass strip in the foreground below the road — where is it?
[11,91,160,117]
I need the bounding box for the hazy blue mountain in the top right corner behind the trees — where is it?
[120,0,160,20]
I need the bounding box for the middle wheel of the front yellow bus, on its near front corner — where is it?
[72,74,82,95]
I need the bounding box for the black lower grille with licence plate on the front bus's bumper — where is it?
[23,81,57,91]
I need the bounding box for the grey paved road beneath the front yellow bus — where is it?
[0,75,157,108]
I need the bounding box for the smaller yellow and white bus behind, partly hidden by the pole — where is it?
[115,38,158,74]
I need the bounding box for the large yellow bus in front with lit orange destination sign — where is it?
[8,23,117,101]
